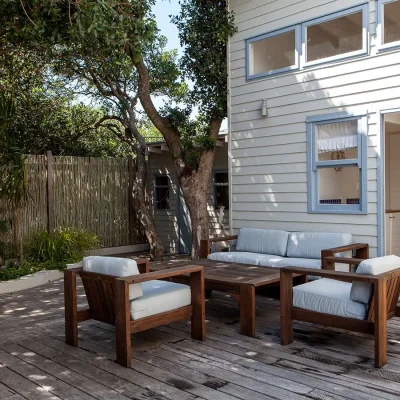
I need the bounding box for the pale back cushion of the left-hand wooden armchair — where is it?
[82,256,143,300]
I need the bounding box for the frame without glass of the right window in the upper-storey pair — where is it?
[300,4,369,67]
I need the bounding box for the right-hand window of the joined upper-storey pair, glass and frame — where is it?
[302,6,368,66]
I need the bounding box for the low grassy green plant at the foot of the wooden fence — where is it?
[25,228,99,263]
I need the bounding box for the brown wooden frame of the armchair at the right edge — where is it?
[280,267,400,368]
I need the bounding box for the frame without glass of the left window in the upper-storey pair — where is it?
[246,25,301,80]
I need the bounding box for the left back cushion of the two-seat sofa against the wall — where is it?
[236,228,289,256]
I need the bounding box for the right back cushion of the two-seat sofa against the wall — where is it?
[287,232,353,259]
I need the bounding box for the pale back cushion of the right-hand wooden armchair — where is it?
[350,255,400,304]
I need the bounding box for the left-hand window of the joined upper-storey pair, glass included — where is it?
[247,27,300,78]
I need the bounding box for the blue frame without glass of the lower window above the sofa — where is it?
[306,113,368,214]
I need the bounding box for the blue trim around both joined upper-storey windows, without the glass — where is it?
[245,0,370,81]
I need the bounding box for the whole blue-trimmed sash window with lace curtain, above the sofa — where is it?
[307,113,368,214]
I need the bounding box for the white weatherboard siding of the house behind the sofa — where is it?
[229,0,400,255]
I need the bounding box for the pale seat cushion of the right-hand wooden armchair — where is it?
[293,278,368,320]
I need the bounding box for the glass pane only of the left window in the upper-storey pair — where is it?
[250,30,296,75]
